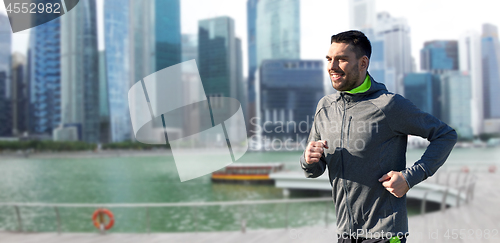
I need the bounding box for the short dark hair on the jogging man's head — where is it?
[330,30,372,59]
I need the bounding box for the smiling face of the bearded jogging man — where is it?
[326,42,368,91]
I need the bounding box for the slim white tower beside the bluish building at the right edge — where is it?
[458,31,484,136]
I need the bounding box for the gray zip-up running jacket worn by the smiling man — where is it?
[300,77,457,235]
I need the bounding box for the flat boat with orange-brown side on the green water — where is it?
[211,163,284,184]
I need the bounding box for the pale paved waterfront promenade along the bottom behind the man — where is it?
[0,172,500,243]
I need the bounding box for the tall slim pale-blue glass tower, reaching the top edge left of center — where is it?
[103,0,132,142]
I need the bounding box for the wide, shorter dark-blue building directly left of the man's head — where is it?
[251,59,324,149]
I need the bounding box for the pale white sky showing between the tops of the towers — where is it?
[0,0,500,76]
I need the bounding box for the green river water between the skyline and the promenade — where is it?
[0,148,500,232]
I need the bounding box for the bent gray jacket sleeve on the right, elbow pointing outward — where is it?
[386,95,457,188]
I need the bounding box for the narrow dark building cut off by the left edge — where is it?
[0,14,12,137]
